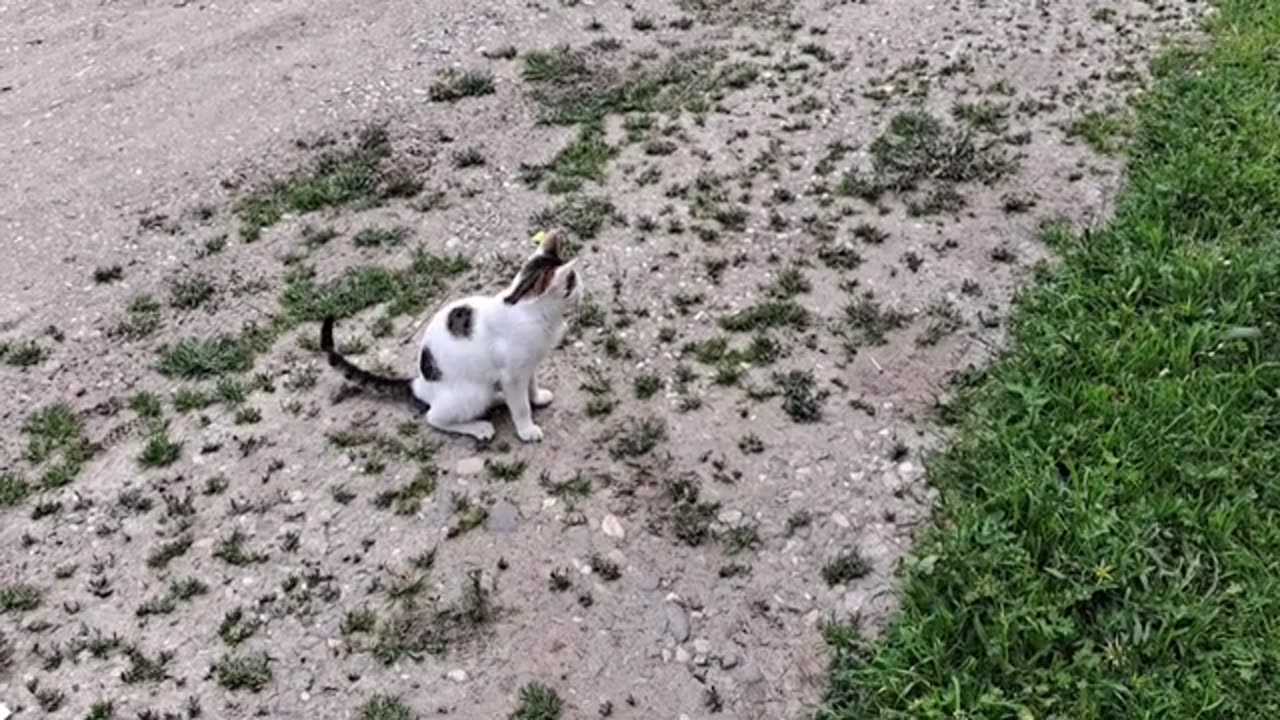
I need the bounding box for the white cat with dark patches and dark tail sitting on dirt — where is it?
[320,233,582,442]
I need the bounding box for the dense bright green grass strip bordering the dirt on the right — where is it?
[818,0,1280,720]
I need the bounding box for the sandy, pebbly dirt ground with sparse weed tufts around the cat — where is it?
[0,0,1202,719]
